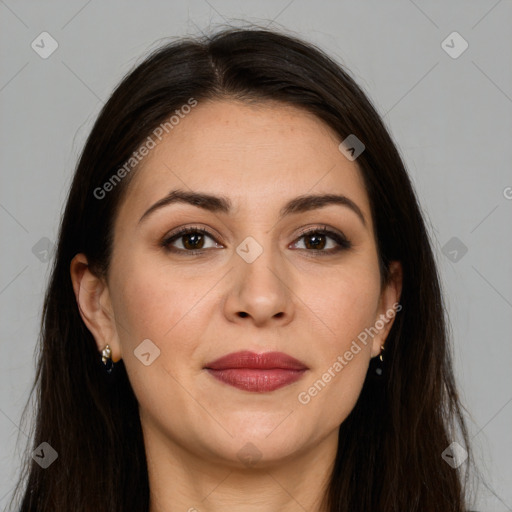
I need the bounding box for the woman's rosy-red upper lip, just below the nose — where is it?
[205,350,308,370]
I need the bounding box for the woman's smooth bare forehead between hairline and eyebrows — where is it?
[119,100,370,226]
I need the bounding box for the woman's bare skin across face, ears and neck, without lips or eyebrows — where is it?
[71,100,402,512]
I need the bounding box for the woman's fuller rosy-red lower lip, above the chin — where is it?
[207,368,306,393]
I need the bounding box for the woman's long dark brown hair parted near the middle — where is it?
[10,28,472,512]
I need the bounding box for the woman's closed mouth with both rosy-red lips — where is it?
[204,351,309,393]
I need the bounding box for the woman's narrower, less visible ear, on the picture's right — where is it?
[372,261,403,357]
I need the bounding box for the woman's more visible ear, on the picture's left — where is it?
[70,254,121,362]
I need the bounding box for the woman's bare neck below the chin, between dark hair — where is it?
[145,430,338,512]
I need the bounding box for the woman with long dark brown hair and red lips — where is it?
[11,29,476,512]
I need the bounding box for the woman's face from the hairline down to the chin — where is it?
[74,100,400,464]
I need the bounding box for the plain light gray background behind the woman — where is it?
[0,0,512,512]
